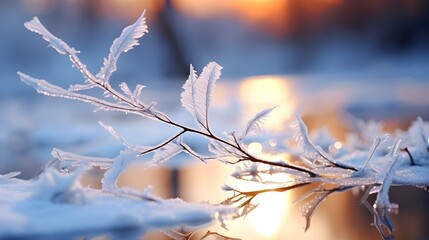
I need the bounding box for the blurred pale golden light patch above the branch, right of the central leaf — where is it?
[239,76,295,131]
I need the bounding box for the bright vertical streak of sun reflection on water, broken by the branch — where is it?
[232,76,295,239]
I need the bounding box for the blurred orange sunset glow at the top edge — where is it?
[171,0,344,35]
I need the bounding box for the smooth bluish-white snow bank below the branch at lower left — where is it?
[0,168,232,239]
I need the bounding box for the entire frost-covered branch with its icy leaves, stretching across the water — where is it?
[18,9,429,239]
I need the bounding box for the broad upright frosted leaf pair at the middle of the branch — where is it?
[180,62,222,130]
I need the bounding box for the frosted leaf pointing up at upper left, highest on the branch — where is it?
[96,12,147,82]
